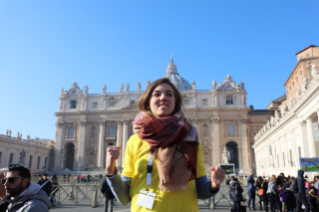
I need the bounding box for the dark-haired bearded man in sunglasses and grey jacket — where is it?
[1,165,51,212]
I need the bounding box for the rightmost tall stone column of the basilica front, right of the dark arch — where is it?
[240,119,252,174]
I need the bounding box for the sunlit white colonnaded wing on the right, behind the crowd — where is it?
[253,52,319,176]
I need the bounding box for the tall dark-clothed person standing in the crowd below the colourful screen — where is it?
[294,169,310,212]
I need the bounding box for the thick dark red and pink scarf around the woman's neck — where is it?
[133,111,198,192]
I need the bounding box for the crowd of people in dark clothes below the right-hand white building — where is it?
[226,170,319,212]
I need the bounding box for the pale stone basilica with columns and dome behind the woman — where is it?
[54,58,273,174]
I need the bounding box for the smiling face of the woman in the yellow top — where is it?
[149,83,175,118]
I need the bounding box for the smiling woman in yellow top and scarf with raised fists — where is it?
[106,78,225,212]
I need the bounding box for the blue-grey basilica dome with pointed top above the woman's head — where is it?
[164,57,192,90]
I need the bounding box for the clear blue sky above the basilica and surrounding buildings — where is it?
[0,0,319,139]
